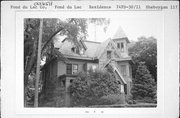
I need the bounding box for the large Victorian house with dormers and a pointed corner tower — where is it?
[41,27,132,106]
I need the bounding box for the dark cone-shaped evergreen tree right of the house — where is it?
[131,62,156,100]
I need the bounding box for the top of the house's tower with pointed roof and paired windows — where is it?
[112,27,129,56]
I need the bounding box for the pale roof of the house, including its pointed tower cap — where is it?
[54,27,131,61]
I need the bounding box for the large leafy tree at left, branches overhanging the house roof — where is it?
[24,18,109,106]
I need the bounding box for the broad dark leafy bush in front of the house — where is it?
[69,71,120,106]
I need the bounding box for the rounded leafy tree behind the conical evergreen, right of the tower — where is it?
[129,37,157,81]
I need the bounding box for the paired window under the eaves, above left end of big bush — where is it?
[66,64,78,74]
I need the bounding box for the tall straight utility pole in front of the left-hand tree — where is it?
[34,19,43,107]
